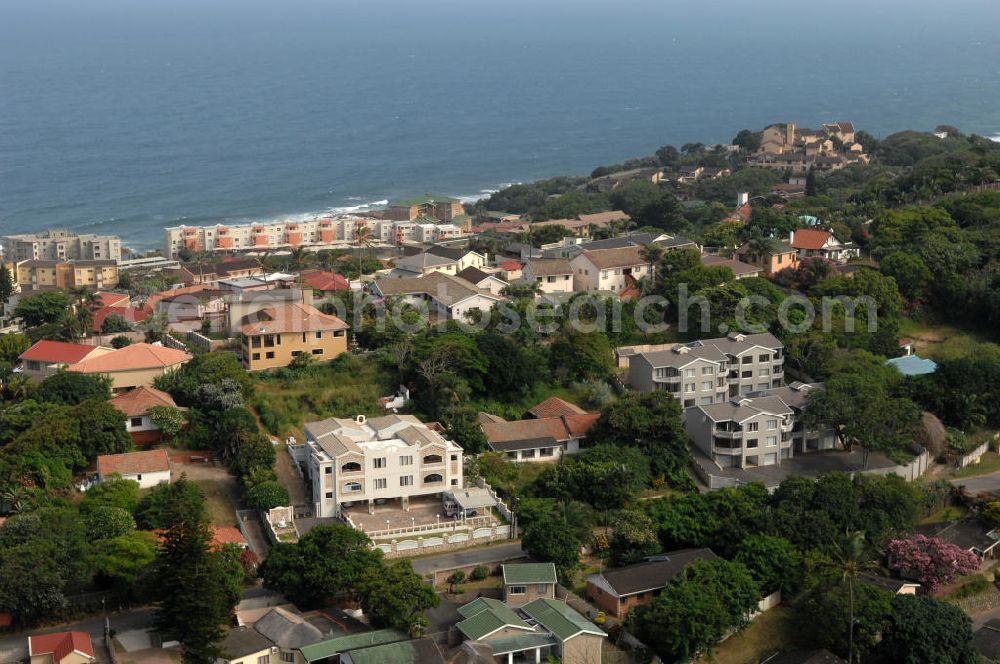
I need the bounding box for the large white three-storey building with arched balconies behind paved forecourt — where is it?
[300,415,462,517]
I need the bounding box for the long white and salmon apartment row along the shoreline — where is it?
[163,216,465,258]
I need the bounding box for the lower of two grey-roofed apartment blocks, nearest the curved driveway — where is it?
[684,383,837,468]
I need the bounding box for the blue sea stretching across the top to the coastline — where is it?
[0,0,1000,247]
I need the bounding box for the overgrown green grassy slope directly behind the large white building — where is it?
[253,355,396,440]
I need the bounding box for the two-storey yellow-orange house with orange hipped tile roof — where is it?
[240,303,348,371]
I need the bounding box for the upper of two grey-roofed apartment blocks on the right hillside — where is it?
[619,333,785,408]
